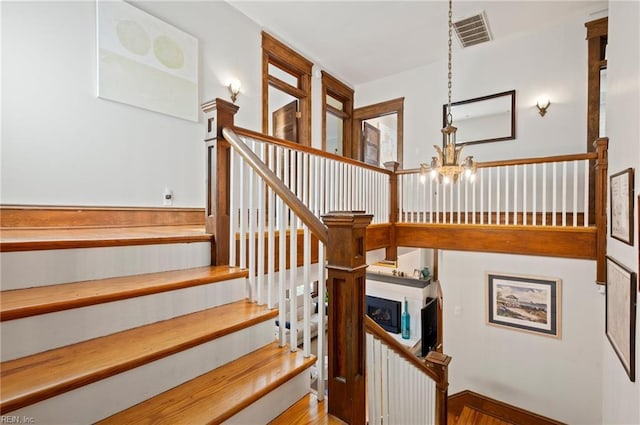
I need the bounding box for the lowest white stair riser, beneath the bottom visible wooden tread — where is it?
[223,369,310,425]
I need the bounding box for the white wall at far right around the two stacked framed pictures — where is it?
[602,1,640,424]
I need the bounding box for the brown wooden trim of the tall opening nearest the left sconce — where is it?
[262,31,313,146]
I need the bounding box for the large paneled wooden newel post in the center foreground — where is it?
[322,212,373,425]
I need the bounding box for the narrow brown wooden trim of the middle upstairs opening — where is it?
[322,71,357,159]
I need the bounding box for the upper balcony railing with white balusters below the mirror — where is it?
[398,152,598,227]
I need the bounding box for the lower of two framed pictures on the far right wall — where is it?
[605,257,638,382]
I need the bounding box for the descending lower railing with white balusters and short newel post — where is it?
[365,317,451,425]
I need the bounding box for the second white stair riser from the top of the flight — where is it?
[1,279,246,361]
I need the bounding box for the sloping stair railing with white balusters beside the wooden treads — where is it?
[222,128,328,399]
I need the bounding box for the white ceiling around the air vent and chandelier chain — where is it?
[228,0,607,86]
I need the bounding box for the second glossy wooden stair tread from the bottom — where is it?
[0,300,278,414]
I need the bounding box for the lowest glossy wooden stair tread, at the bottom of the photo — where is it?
[98,343,315,425]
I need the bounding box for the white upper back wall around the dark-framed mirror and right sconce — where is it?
[355,14,590,168]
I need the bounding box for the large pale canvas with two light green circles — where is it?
[96,0,200,121]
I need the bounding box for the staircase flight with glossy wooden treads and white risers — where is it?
[0,220,315,424]
